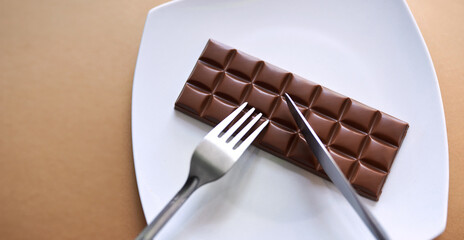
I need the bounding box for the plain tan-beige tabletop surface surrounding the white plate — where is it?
[0,0,464,239]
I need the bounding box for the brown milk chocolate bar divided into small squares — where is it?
[175,40,408,200]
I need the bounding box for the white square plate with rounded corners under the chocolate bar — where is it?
[132,0,448,240]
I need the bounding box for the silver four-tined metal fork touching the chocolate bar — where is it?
[136,102,269,240]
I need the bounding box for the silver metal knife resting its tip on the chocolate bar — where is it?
[285,93,390,239]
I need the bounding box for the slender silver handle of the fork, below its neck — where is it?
[135,176,199,240]
